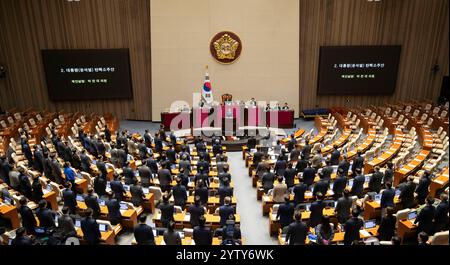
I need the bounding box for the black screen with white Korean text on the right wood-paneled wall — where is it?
[317,45,401,95]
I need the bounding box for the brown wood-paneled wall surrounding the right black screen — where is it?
[299,0,449,109]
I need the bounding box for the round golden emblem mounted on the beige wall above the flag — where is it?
[210,31,242,64]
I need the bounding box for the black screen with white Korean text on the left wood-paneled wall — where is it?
[42,49,133,101]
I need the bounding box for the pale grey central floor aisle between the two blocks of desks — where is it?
[227,152,278,245]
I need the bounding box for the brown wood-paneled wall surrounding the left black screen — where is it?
[0,0,151,120]
